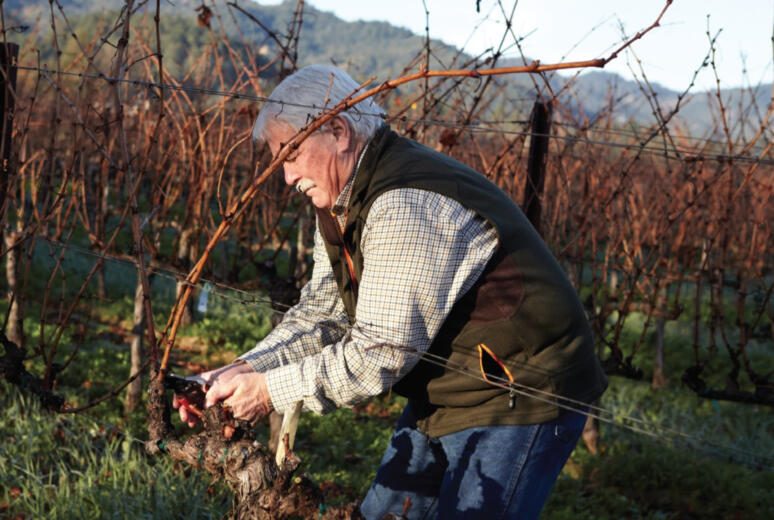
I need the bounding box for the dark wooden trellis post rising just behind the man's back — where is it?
[522,101,551,233]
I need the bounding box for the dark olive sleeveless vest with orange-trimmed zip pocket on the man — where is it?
[318,127,607,437]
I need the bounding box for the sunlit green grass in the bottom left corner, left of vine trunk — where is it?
[0,380,230,520]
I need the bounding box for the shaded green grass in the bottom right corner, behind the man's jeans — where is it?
[542,378,774,520]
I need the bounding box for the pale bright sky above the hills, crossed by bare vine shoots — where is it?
[258,0,774,90]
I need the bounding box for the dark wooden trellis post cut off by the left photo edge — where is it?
[0,43,19,215]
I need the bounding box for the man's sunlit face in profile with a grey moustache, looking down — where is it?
[267,123,350,209]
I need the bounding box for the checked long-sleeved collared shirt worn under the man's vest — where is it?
[241,171,497,414]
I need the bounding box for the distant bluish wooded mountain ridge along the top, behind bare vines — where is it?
[3,0,771,132]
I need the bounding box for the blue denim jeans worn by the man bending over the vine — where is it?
[361,405,586,520]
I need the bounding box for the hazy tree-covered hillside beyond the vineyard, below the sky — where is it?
[3,0,771,134]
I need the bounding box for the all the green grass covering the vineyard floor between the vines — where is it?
[0,246,774,520]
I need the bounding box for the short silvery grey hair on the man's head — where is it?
[253,65,384,145]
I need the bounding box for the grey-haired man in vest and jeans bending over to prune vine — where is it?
[180,65,607,519]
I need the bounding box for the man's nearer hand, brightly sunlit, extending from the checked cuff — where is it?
[205,371,272,423]
